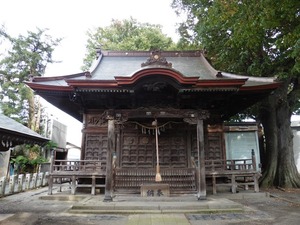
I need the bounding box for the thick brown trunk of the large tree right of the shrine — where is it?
[260,81,300,188]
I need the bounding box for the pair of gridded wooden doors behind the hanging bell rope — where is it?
[120,123,188,168]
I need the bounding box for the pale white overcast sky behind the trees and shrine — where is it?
[0,0,181,146]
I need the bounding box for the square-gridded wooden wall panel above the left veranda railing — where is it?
[84,133,107,163]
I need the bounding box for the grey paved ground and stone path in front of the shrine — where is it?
[0,185,300,225]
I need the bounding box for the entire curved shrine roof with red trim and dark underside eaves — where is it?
[27,51,280,121]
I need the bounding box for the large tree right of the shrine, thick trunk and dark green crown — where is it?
[173,0,300,187]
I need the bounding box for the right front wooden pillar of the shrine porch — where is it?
[197,118,206,200]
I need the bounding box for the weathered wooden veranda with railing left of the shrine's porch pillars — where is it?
[48,160,106,195]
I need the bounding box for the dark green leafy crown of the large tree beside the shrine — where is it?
[173,0,300,77]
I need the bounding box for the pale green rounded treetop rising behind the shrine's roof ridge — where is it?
[82,18,175,70]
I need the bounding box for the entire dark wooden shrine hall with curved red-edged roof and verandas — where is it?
[27,50,279,201]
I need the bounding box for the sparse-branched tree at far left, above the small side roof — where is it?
[0,27,60,132]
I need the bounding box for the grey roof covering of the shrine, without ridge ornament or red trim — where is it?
[33,51,275,87]
